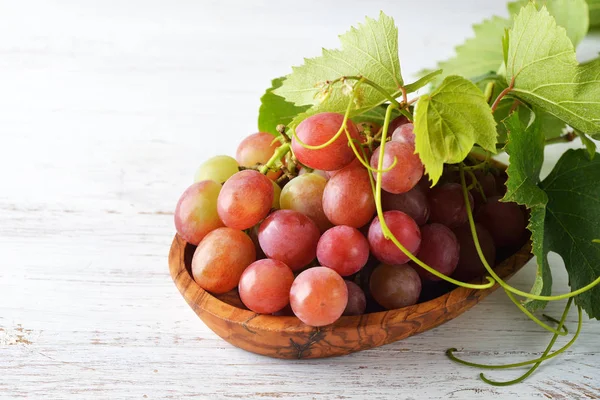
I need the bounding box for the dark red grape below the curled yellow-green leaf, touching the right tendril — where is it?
[428,183,473,228]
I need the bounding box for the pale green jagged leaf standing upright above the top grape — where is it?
[275,13,404,116]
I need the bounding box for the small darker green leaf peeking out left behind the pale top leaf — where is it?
[258,77,308,135]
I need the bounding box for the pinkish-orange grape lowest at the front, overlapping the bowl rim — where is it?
[290,267,348,326]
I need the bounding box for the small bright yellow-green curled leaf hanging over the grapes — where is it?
[414,76,496,185]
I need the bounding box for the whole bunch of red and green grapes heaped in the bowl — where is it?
[175,113,526,326]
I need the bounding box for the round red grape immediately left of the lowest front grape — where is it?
[238,259,294,314]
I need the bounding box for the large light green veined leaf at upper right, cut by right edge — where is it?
[506,4,600,136]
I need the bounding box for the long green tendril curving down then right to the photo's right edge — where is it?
[459,163,600,301]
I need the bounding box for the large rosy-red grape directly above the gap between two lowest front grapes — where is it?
[258,210,319,271]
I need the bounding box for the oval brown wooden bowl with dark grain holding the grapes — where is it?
[169,231,532,359]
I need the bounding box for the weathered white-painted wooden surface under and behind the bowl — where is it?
[0,0,600,399]
